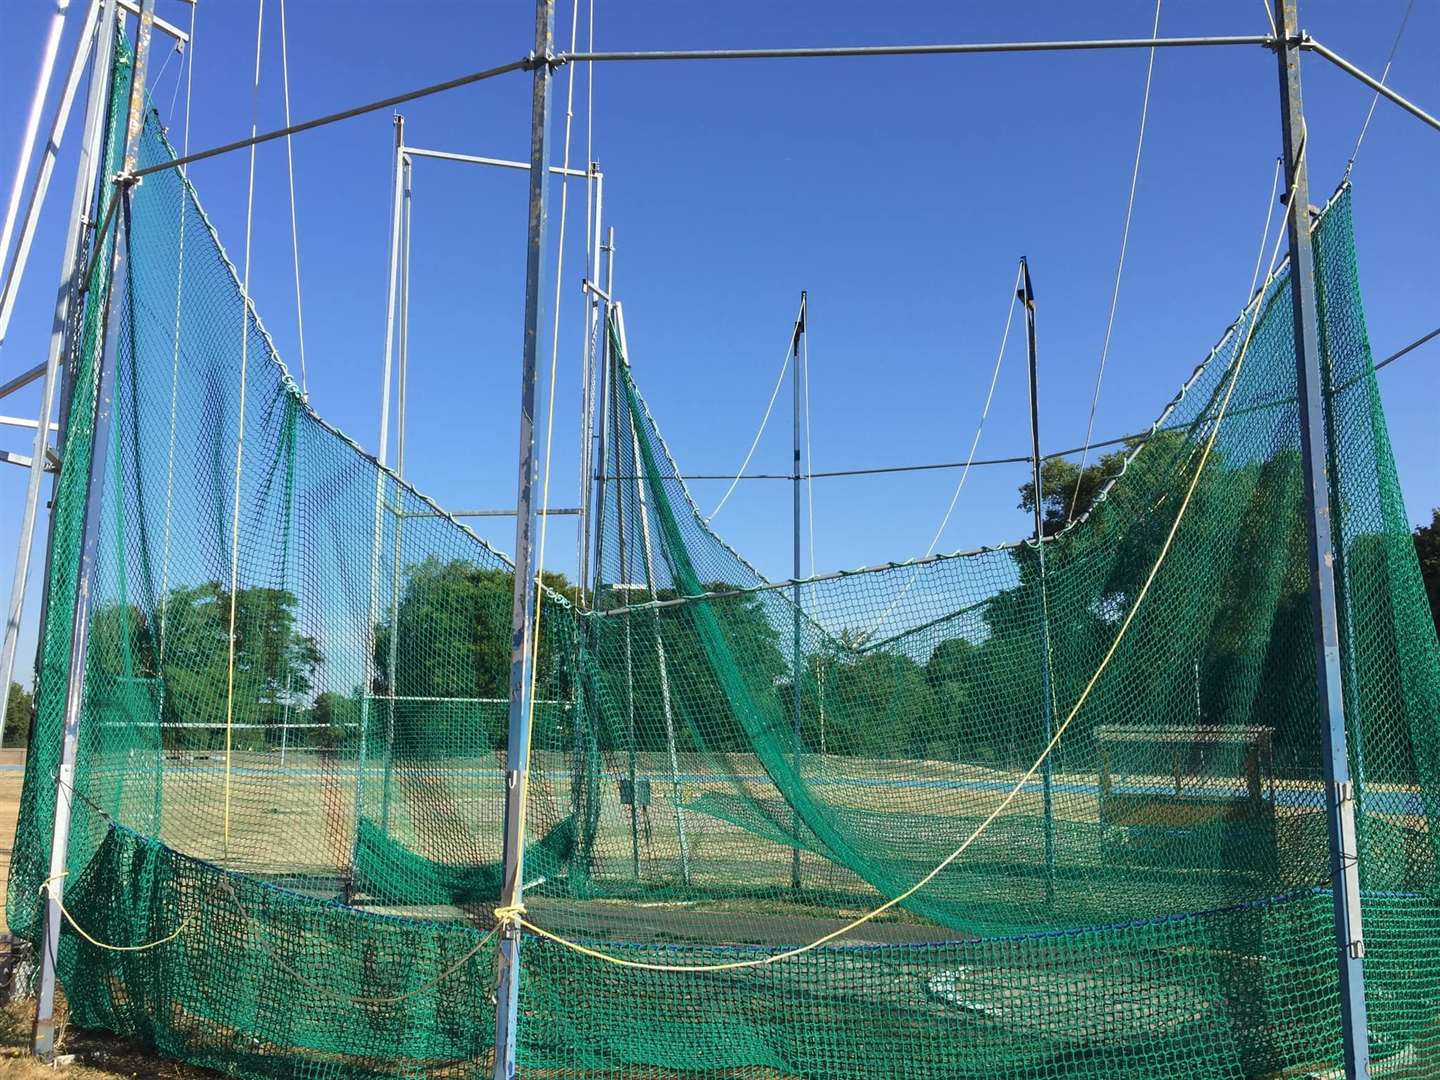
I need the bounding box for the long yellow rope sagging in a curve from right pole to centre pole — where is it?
[495,160,1305,973]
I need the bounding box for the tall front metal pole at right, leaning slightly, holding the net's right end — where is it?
[1274,0,1369,1080]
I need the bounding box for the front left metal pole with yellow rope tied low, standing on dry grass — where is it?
[33,0,156,1057]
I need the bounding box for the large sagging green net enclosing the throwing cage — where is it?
[9,31,1440,1080]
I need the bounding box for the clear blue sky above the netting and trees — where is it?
[0,0,1440,681]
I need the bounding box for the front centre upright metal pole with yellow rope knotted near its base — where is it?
[495,0,554,1080]
